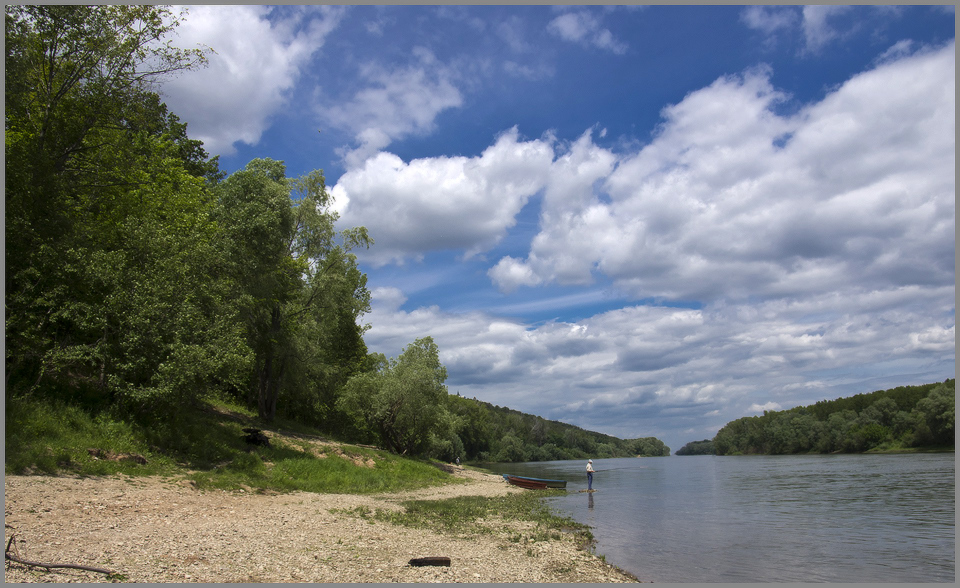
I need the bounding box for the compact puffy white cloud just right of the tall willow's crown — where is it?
[331,129,553,265]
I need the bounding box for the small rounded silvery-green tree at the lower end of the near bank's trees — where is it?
[338,337,453,455]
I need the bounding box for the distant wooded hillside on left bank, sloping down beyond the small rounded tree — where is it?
[449,395,670,462]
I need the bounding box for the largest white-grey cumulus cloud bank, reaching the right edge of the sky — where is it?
[491,44,955,301]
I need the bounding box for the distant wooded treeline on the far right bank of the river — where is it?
[677,379,956,455]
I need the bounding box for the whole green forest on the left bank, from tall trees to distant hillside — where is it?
[5,5,669,461]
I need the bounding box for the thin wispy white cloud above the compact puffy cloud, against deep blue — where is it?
[321,48,463,168]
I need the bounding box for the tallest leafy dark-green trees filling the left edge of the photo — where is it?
[5,6,242,408]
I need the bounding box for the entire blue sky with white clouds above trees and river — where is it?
[160,5,956,451]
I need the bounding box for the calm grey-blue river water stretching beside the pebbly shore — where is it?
[487,453,956,583]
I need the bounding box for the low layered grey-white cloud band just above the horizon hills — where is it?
[365,286,954,449]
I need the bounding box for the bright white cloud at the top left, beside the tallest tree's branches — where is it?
[161,5,344,155]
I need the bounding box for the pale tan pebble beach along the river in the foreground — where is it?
[4,468,636,583]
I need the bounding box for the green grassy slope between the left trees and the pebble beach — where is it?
[4,397,451,494]
